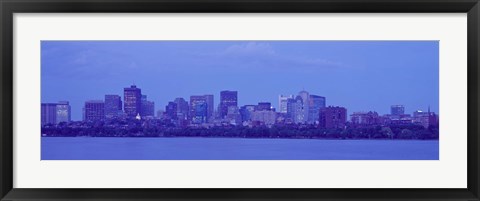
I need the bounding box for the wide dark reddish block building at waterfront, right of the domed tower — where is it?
[319,106,347,128]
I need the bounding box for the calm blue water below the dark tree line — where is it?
[42,137,439,160]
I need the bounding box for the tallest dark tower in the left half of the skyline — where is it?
[123,85,142,117]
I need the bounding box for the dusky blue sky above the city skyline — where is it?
[41,41,439,120]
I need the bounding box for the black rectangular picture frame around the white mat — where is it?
[0,0,480,201]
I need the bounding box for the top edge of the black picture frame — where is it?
[2,0,478,13]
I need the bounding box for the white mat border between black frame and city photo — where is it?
[13,13,467,188]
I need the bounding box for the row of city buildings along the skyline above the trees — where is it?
[42,85,438,126]
